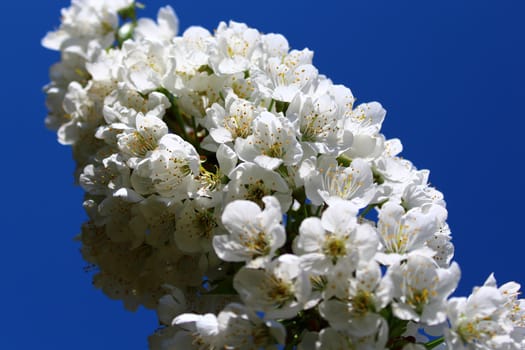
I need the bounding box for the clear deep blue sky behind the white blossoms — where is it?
[0,0,525,350]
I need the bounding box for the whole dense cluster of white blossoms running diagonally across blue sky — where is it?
[43,0,525,350]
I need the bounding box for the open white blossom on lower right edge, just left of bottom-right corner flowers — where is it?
[387,254,460,325]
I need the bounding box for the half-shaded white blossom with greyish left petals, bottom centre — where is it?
[233,254,310,319]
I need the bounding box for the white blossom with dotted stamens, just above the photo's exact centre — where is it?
[235,112,303,170]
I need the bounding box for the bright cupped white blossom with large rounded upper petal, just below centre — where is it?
[213,197,286,262]
